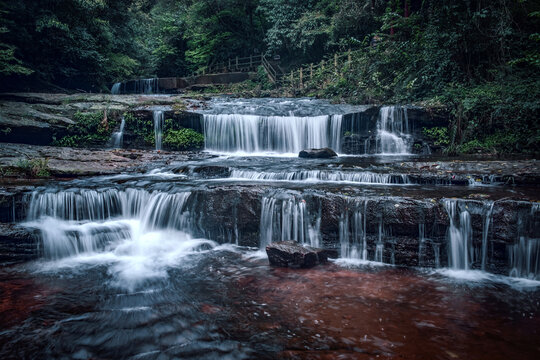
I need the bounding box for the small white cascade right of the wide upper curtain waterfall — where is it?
[377,106,412,154]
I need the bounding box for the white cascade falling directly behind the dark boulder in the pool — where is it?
[260,196,321,249]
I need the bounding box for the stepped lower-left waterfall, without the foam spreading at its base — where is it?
[27,189,196,259]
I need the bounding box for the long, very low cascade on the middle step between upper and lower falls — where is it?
[230,169,410,184]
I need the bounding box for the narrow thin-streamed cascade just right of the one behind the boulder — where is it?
[339,199,369,260]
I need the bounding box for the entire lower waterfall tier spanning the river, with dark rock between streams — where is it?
[19,185,540,279]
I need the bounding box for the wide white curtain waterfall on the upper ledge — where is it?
[204,114,343,153]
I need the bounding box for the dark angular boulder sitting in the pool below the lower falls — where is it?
[266,241,328,268]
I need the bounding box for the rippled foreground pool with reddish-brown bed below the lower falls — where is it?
[0,250,540,360]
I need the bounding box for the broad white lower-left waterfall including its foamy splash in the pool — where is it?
[26,189,217,290]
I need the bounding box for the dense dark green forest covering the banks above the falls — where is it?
[0,0,540,152]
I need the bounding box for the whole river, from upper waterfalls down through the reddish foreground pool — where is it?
[0,99,540,359]
